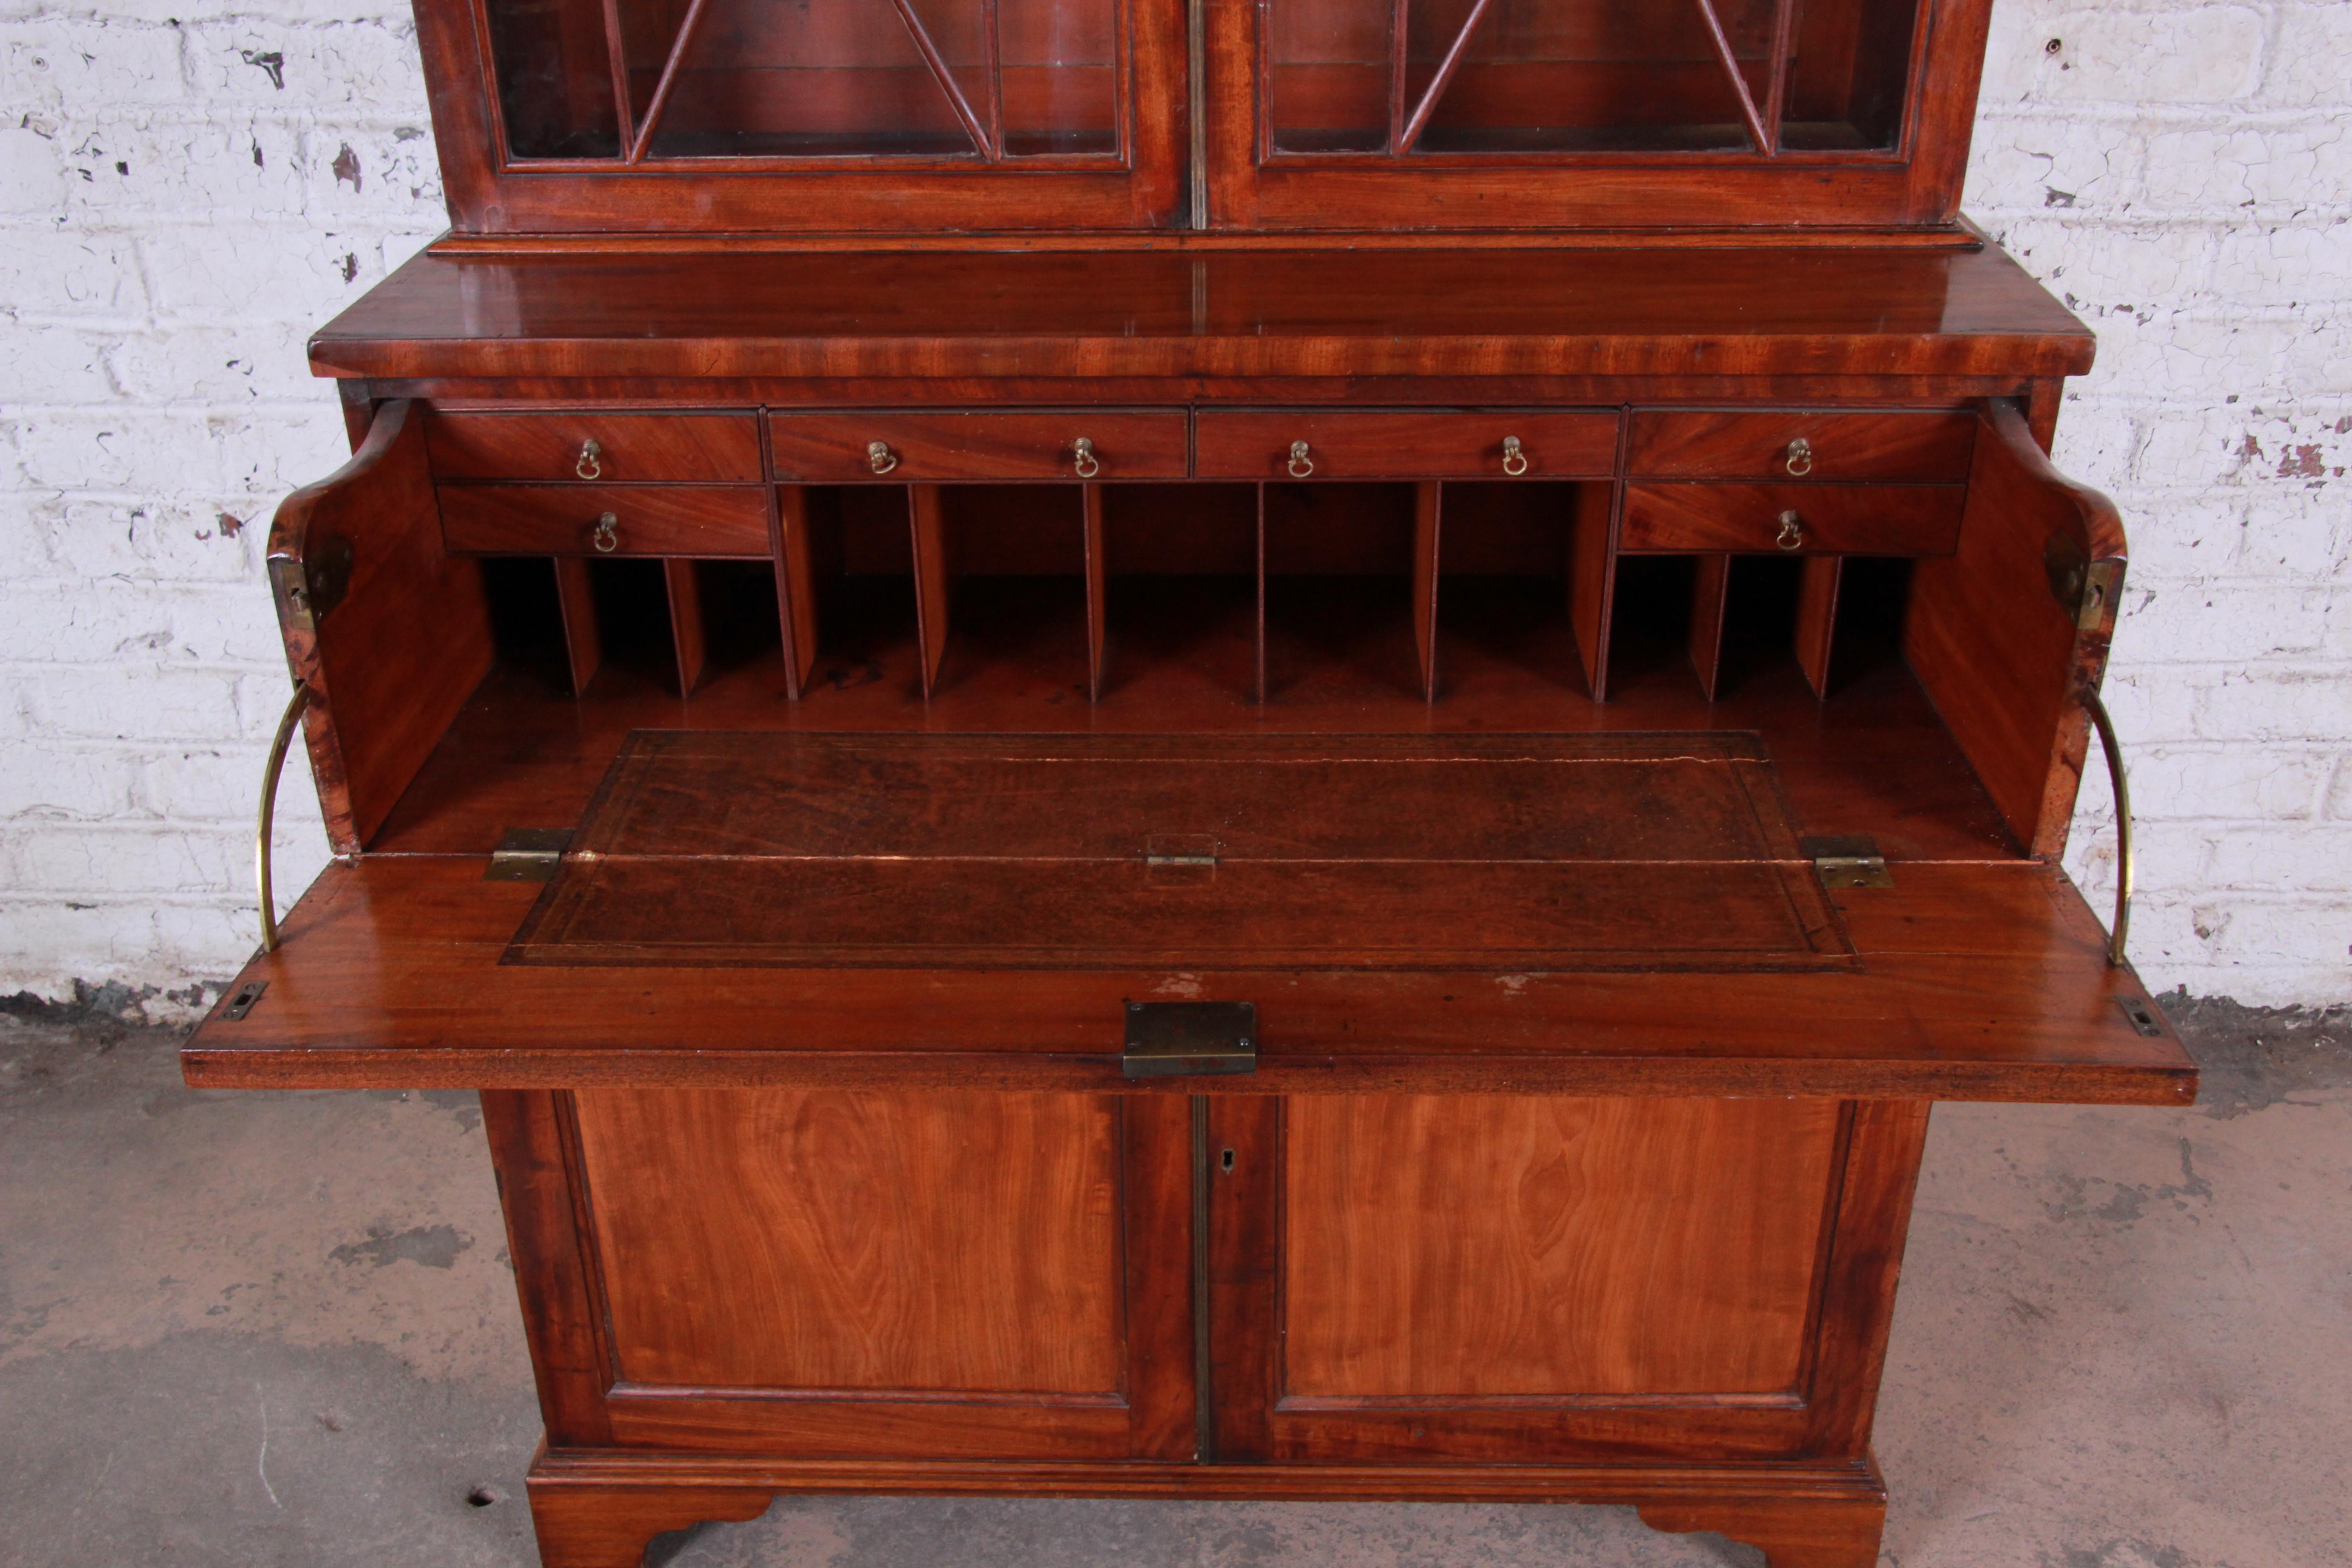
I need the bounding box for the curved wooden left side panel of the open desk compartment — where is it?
[268,402,494,853]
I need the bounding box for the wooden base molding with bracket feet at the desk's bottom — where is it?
[529,1448,1886,1568]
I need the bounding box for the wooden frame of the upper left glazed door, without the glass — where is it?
[416,0,1190,237]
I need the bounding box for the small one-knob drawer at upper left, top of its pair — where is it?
[426,412,764,484]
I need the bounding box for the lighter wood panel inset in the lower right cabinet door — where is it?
[1282,1096,1839,1408]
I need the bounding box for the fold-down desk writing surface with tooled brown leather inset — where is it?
[186,731,2195,1102]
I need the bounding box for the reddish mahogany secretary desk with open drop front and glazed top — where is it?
[183,0,2197,1568]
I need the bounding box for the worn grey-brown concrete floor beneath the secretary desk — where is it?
[0,1004,2352,1568]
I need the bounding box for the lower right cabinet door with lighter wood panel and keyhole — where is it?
[1206,1096,1926,1462]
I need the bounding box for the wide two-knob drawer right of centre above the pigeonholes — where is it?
[1195,412,1616,480]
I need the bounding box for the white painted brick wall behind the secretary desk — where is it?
[0,0,2352,1011]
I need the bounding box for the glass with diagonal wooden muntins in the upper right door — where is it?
[1265,0,1917,157]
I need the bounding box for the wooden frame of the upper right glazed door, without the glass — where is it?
[1197,0,1992,230]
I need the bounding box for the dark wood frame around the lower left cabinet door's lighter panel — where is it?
[482,1088,1200,1462]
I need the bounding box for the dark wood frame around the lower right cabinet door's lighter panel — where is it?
[1202,1096,1931,1465]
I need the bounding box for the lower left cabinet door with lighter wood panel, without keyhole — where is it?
[501,1088,1197,1460]
